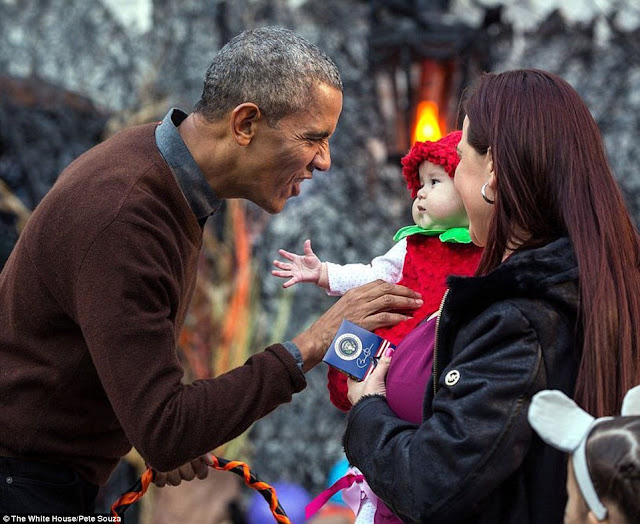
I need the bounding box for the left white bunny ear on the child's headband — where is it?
[528,390,594,453]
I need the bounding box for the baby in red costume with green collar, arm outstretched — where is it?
[272,131,482,411]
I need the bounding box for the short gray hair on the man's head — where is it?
[195,27,342,126]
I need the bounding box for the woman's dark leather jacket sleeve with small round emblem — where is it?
[344,305,545,524]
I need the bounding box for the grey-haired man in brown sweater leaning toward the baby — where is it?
[0,27,421,514]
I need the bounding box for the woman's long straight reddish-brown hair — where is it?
[464,69,640,416]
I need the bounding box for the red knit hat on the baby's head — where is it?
[401,131,462,198]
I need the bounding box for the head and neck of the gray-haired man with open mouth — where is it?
[178,28,342,213]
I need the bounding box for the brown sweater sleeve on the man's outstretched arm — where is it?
[75,221,306,471]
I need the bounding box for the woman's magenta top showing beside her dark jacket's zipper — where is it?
[386,317,437,424]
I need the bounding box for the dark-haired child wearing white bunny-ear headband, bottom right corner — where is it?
[529,386,640,524]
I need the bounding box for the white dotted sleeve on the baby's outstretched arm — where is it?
[327,239,407,296]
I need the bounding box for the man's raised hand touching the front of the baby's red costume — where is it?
[293,280,422,371]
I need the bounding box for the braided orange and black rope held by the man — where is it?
[111,454,291,524]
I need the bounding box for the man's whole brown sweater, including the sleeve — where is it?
[0,124,306,484]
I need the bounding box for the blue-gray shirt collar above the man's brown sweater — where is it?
[156,108,222,226]
